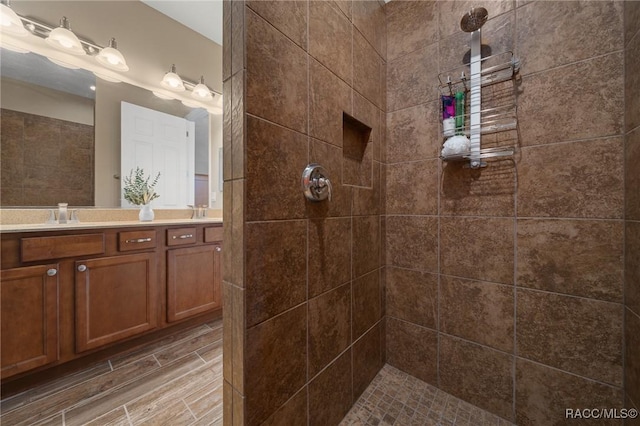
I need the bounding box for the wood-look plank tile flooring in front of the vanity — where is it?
[0,320,222,426]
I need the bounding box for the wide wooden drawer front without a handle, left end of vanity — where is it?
[20,234,104,262]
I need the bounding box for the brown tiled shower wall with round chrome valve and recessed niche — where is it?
[223,0,387,426]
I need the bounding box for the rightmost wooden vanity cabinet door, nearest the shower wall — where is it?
[167,244,222,322]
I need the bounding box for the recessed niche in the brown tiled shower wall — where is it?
[342,113,373,188]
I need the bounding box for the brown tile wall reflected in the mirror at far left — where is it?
[0,109,95,206]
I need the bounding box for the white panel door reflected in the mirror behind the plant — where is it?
[120,102,195,208]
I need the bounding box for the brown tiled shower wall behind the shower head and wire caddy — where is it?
[381,0,628,425]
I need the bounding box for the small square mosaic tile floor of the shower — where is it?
[340,364,513,426]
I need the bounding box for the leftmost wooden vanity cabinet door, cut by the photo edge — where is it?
[0,265,58,379]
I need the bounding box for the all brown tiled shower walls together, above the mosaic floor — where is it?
[224,0,640,425]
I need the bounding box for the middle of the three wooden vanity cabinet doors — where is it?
[75,253,158,352]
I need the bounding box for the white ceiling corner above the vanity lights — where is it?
[141,0,222,45]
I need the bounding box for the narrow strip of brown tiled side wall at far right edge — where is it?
[624,1,640,426]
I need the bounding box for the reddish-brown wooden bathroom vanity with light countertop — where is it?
[0,220,222,387]
